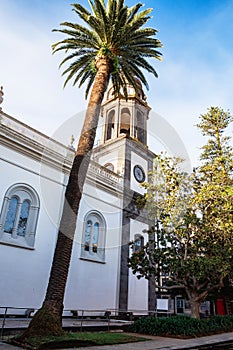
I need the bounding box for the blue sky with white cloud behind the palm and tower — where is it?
[0,0,233,165]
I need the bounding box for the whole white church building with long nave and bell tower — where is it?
[0,85,155,314]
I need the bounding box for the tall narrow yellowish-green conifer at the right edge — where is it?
[195,107,233,239]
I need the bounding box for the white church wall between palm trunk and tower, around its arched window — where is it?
[65,184,121,310]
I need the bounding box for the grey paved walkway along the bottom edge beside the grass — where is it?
[0,320,233,350]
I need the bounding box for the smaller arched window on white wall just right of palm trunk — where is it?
[81,211,106,262]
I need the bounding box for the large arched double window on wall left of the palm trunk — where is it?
[0,184,40,248]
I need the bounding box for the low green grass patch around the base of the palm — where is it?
[9,332,148,350]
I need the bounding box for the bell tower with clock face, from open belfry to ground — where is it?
[93,82,155,312]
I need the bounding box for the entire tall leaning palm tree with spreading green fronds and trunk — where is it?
[17,0,162,339]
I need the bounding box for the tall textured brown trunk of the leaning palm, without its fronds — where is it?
[18,56,111,343]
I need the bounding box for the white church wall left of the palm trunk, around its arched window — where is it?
[0,141,67,308]
